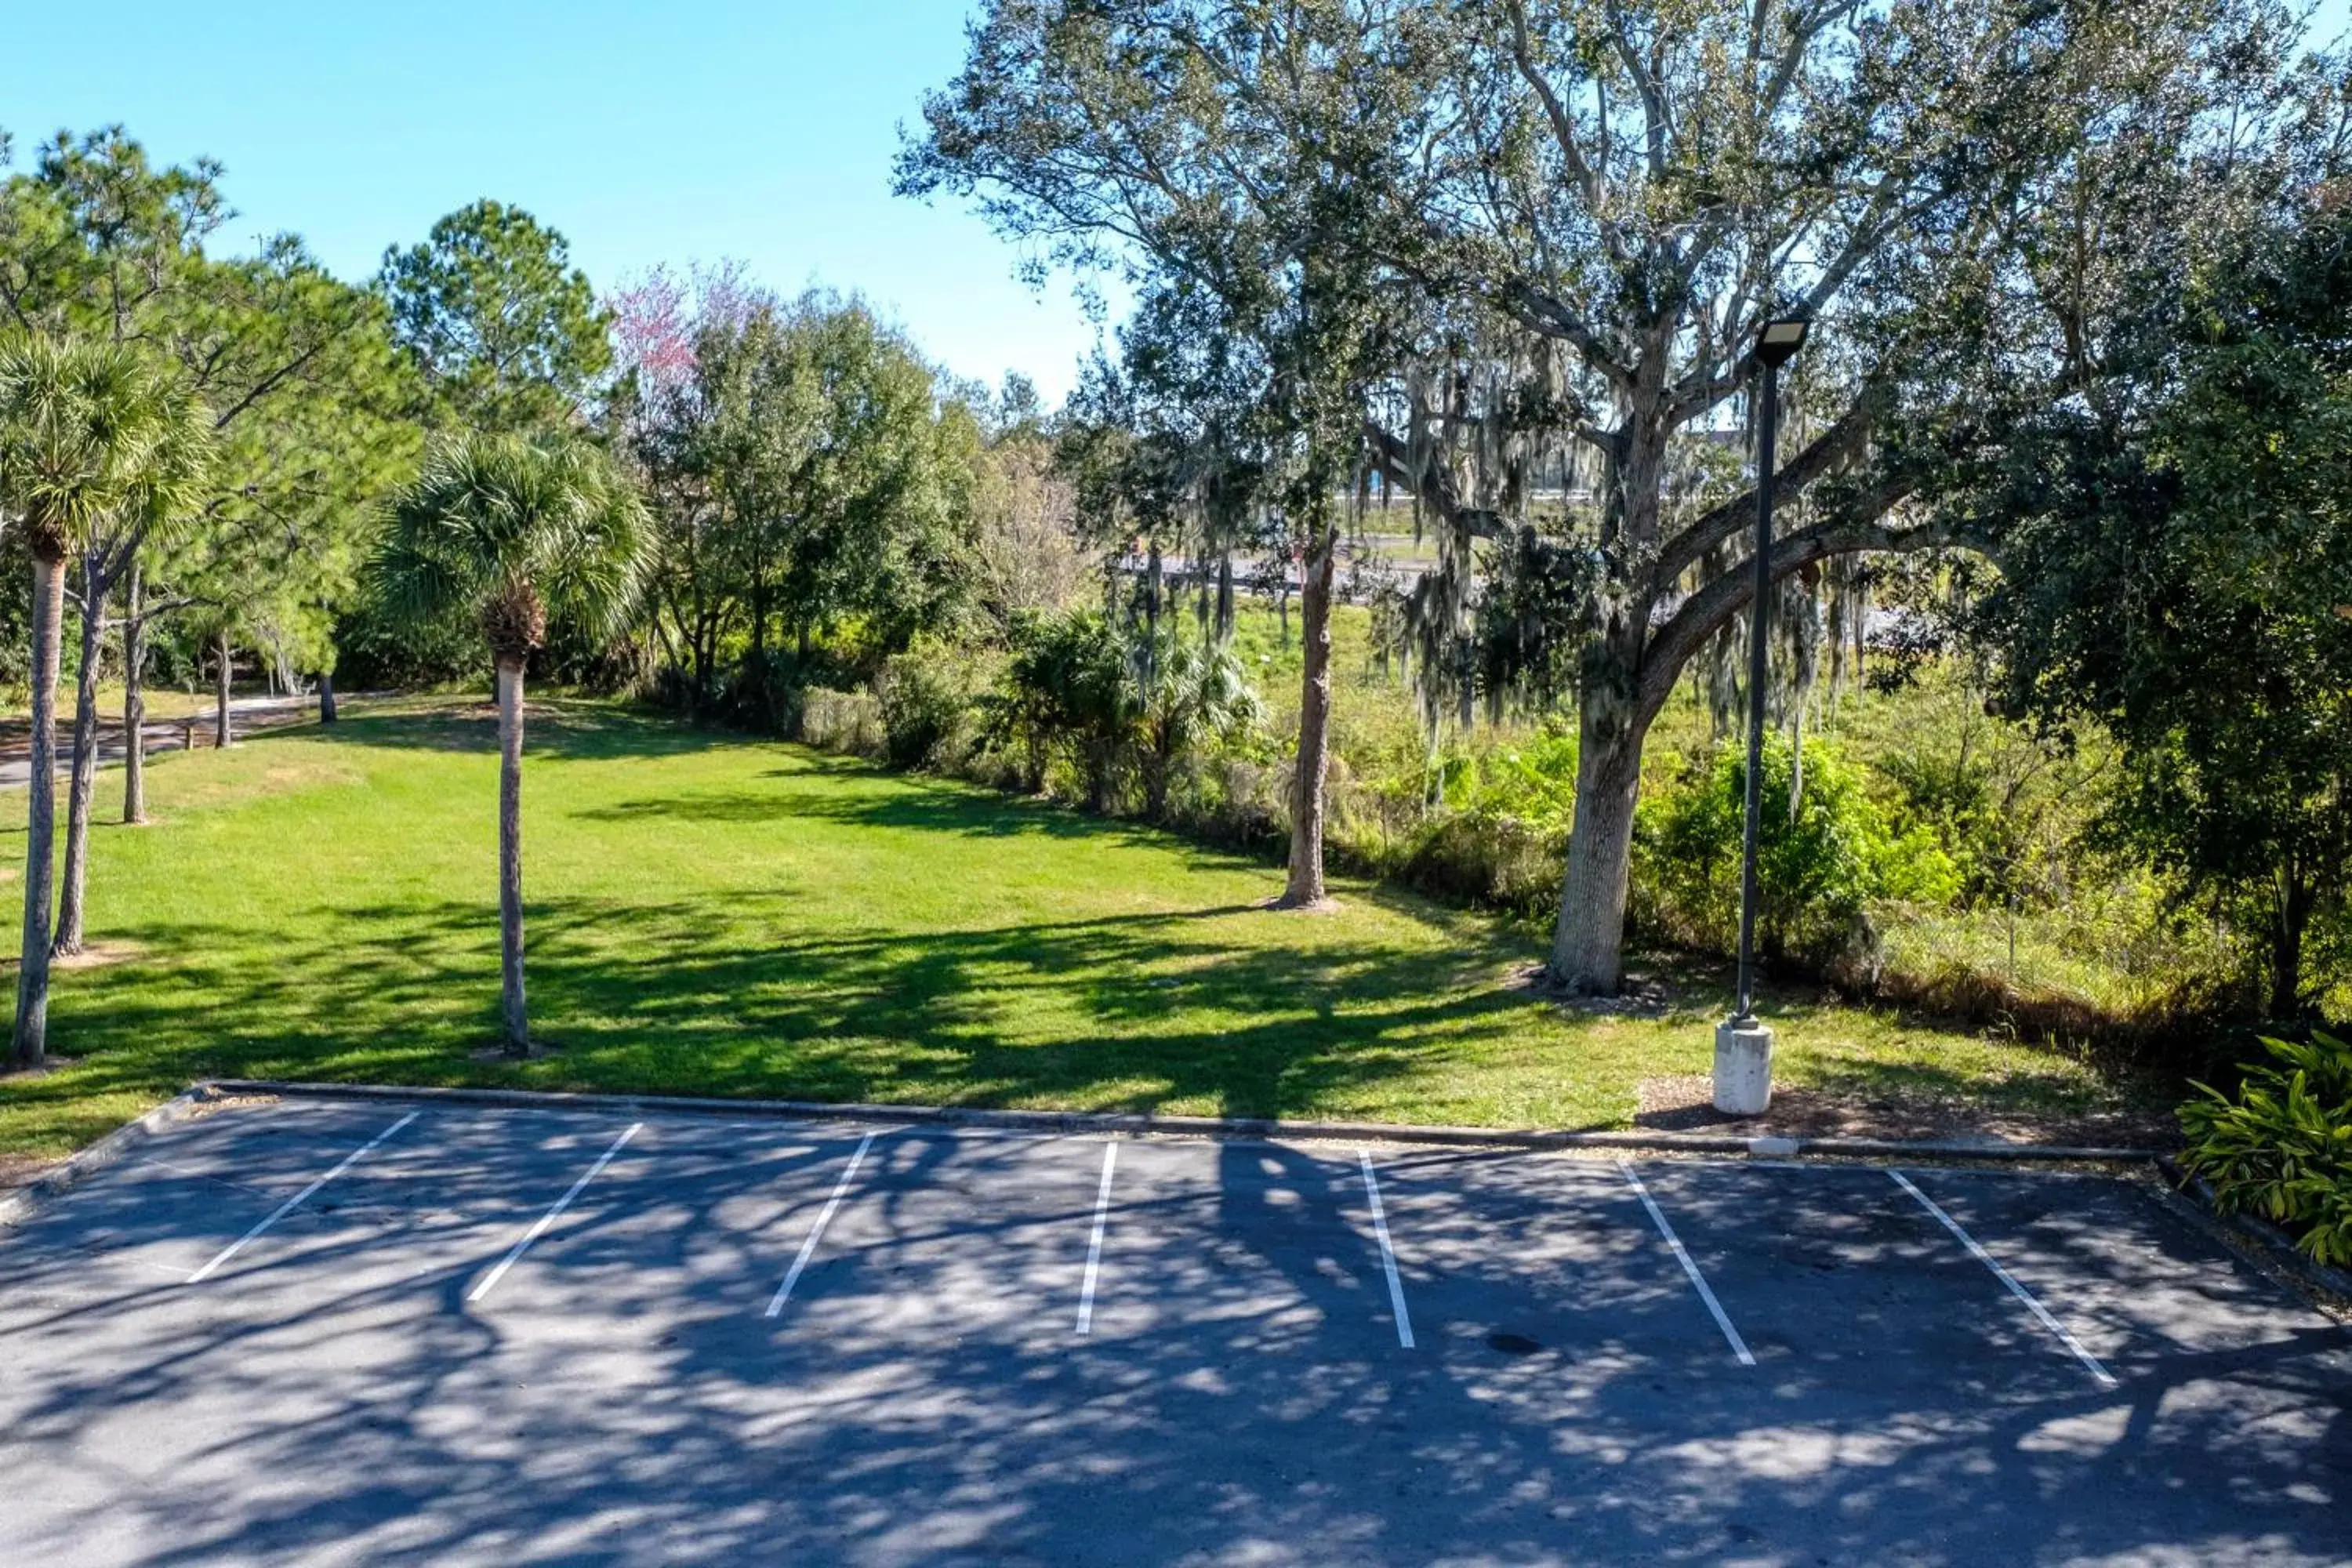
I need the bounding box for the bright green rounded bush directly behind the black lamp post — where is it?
[1635,736,1959,964]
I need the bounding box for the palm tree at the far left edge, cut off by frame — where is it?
[0,336,195,1067]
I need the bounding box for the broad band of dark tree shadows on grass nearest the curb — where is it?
[36,895,1529,1114]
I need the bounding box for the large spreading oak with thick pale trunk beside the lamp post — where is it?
[1392,0,2291,992]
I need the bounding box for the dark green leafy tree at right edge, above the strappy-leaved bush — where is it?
[1978,190,2352,1018]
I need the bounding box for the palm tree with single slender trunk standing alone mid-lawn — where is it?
[374,435,647,1055]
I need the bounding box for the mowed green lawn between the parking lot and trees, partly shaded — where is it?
[0,701,2112,1154]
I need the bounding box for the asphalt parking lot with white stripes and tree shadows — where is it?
[0,1100,2352,1566]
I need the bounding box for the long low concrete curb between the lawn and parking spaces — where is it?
[188,1079,2157,1163]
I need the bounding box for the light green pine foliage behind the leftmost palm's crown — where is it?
[0,127,419,670]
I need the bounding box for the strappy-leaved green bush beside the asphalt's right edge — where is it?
[2180,1032,2352,1265]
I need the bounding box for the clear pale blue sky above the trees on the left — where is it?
[0,0,1096,397]
